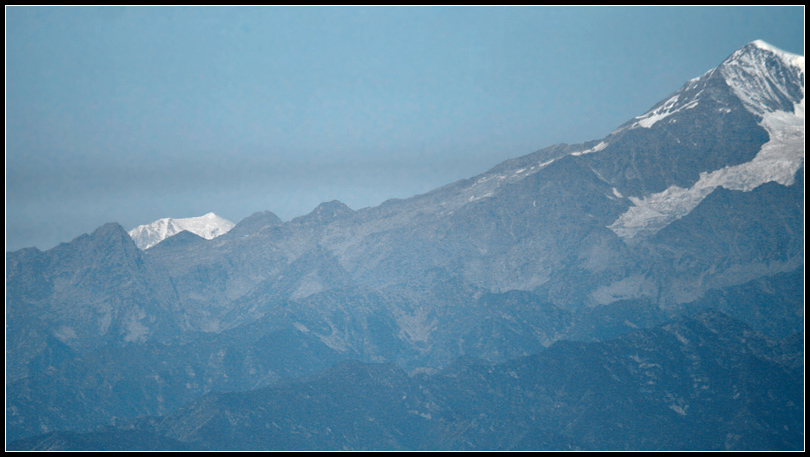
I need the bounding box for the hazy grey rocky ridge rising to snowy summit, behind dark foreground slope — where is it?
[6,42,804,449]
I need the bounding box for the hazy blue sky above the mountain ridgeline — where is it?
[6,7,804,251]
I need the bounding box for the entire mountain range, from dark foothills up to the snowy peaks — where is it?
[6,41,804,450]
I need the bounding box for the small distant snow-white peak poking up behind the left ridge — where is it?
[129,213,236,249]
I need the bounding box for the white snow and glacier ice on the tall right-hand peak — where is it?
[608,40,805,239]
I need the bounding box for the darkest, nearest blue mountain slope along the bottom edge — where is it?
[12,311,804,450]
